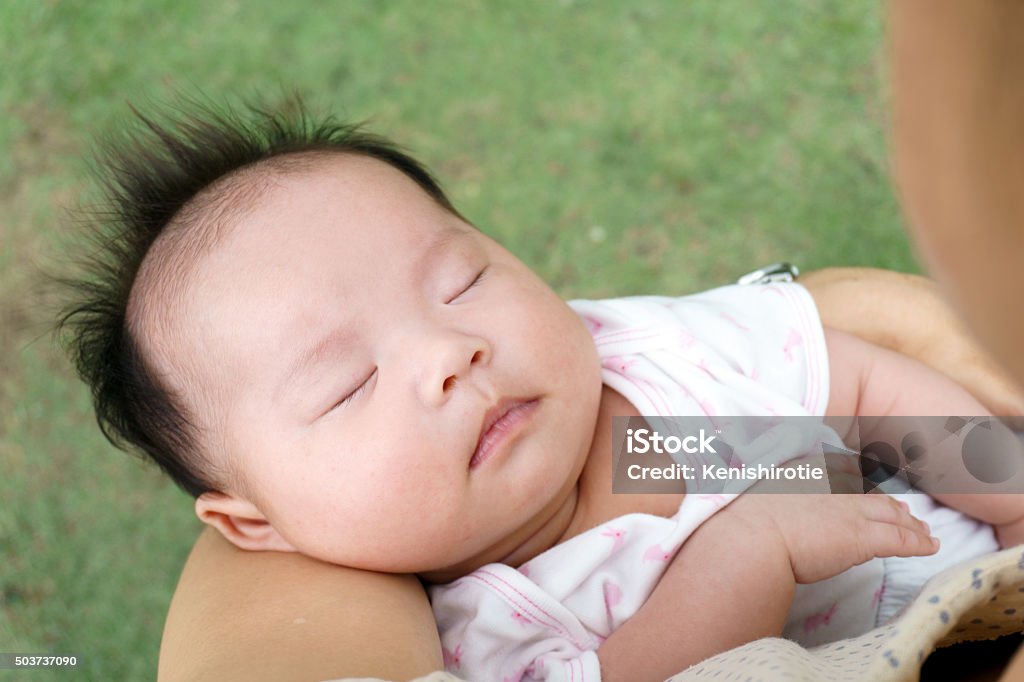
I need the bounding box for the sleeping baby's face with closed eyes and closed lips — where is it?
[180,157,601,572]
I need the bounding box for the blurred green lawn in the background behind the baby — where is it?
[0,0,916,681]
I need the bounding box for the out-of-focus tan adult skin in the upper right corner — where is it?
[889,0,1024,681]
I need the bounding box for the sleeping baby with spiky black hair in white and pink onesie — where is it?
[63,102,1024,681]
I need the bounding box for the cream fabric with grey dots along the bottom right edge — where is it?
[337,547,1024,682]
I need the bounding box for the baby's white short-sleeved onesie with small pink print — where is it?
[430,284,835,682]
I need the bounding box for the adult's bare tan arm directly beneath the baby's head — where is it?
[158,528,441,682]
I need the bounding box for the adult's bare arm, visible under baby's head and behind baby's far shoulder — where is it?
[158,268,1024,682]
